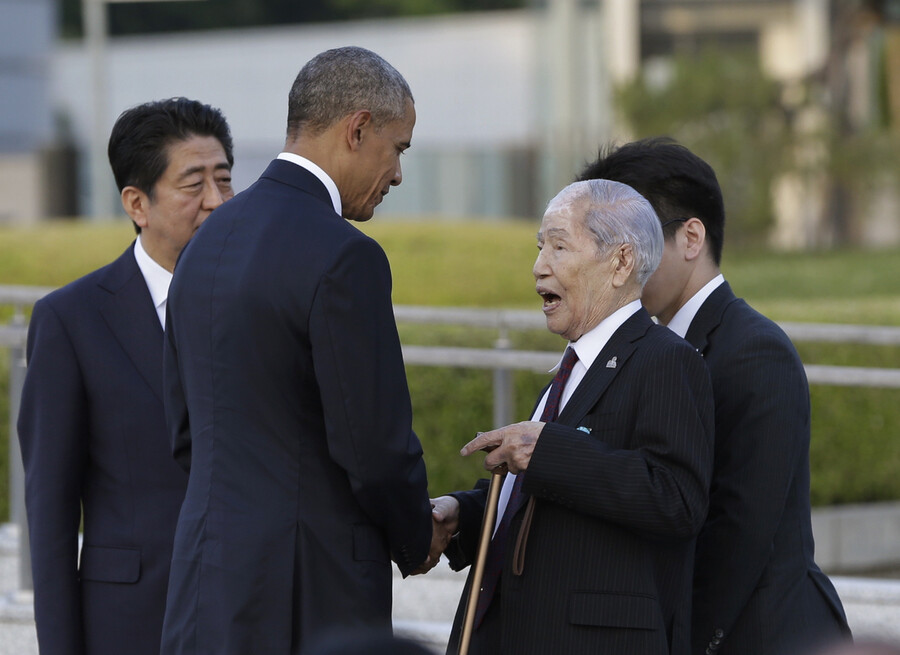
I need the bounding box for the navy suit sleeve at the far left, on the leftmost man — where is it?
[18,301,89,655]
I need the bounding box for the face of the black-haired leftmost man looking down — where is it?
[139,136,234,270]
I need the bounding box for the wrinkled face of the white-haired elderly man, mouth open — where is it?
[533,200,615,341]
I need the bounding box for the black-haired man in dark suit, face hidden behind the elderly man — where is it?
[580,139,849,655]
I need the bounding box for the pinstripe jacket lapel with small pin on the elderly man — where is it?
[556,307,653,426]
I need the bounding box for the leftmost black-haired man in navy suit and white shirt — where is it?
[18,98,233,655]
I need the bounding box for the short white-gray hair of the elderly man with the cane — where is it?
[550,180,663,288]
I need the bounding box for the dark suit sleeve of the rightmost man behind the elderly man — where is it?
[694,332,810,648]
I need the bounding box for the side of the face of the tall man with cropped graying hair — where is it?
[341,99,416,221]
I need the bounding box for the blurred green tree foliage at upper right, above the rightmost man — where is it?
[616,43,900,246]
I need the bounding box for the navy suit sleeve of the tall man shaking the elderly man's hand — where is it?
[310,238,431,575]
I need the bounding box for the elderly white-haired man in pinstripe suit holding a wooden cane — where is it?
[434,180,713,655]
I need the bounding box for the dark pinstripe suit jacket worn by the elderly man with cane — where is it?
[448,309,713,655]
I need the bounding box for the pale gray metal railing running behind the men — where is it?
[0,286,900,589]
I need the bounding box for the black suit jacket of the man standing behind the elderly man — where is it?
[686,283,849,655]
